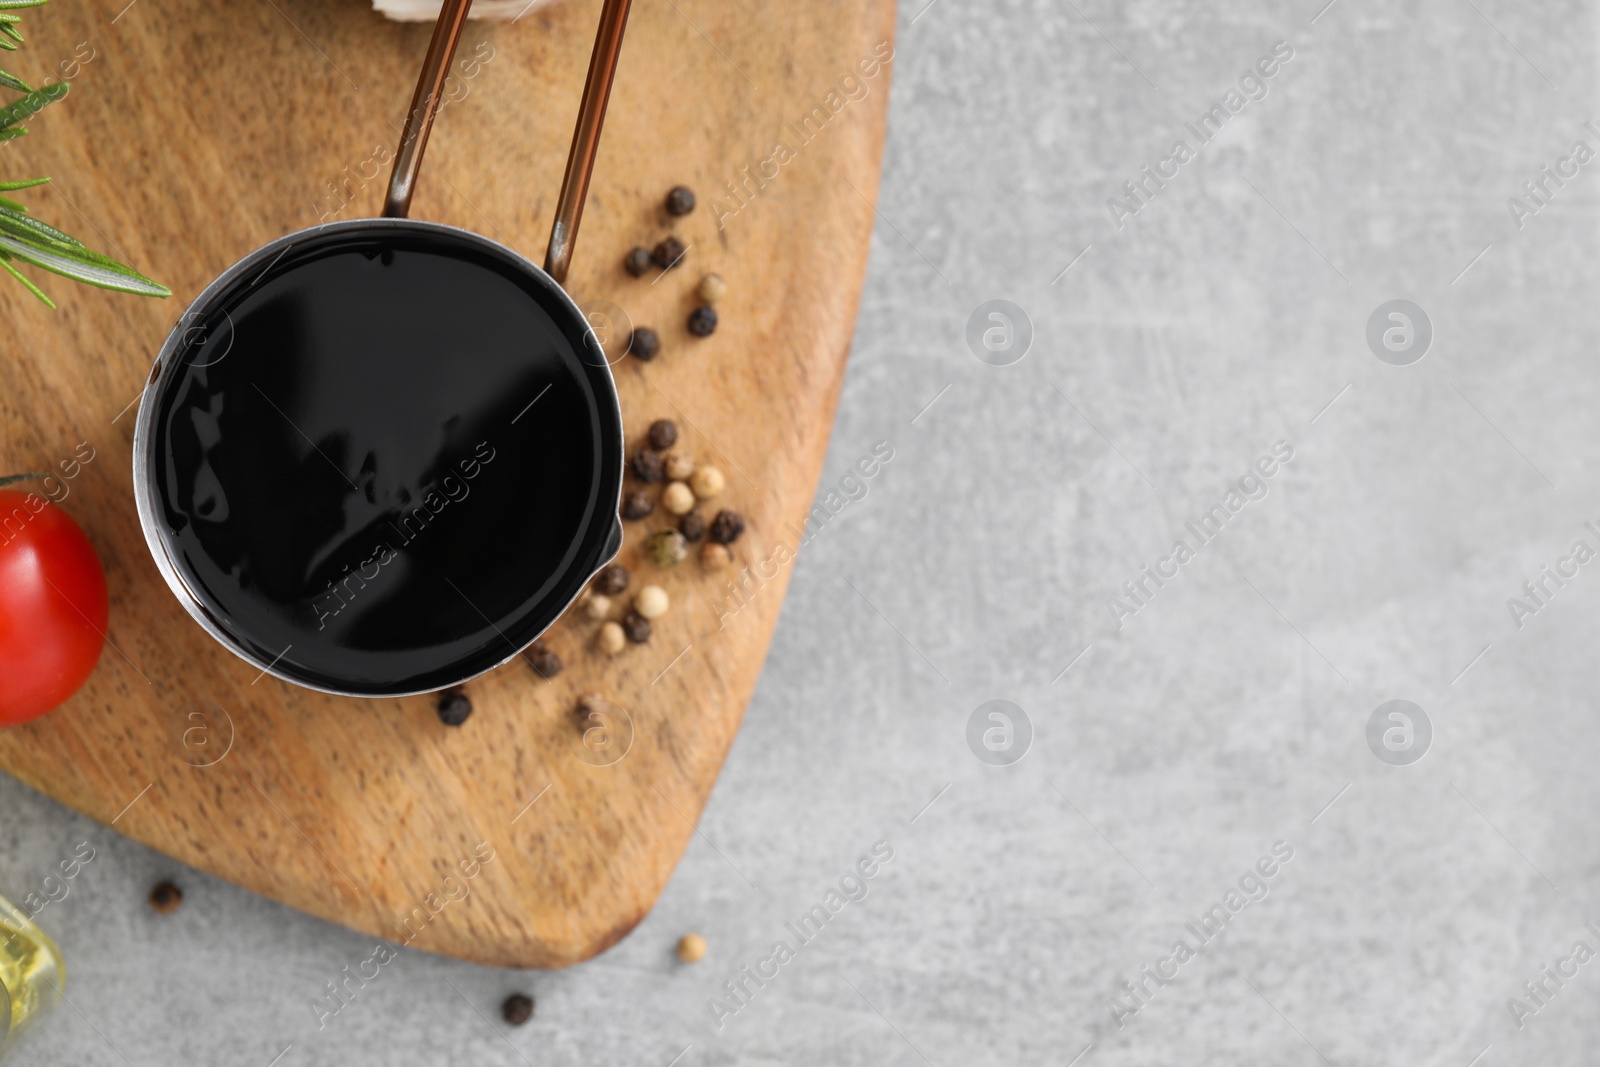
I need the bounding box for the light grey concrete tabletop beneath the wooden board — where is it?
[0,0,1600,1067]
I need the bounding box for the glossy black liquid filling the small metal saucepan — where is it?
[152,230,621,693]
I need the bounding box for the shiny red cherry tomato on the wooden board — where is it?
[0,490,107,726]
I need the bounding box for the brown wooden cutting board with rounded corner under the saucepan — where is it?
[0,0,894,968]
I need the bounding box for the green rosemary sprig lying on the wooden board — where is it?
[0,0,171,307]
